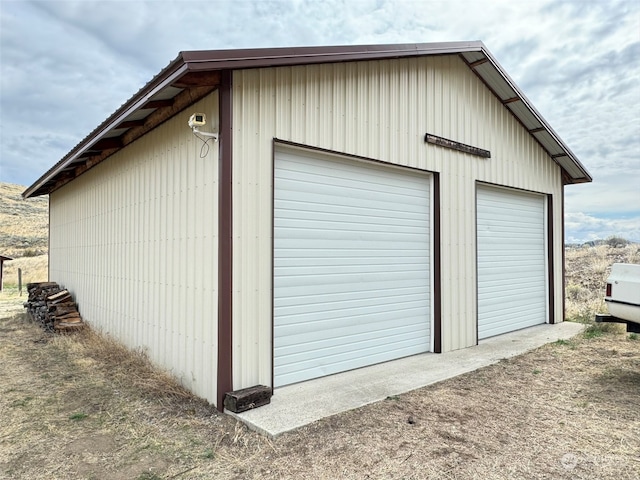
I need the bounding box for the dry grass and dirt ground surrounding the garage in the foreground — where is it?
[0,288,640,480]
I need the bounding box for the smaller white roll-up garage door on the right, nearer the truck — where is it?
[477,186,547,339]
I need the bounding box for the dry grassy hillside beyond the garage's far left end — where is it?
[0,182,49,258]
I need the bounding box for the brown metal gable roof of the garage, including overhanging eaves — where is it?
[23,42,592,198]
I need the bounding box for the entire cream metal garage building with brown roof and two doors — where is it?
[24,42,591,408]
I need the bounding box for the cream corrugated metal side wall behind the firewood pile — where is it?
[50,94,218,403]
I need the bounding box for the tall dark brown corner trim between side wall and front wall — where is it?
[216,70,233,412]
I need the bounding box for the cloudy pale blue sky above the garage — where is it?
[0,0,640,242]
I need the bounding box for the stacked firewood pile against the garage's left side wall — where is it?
[24,282,84,332]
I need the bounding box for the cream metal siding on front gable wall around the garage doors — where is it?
[233,55,563,388]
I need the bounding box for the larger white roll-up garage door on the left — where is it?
[274,150,430,387]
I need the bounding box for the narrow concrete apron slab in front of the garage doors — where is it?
[226,322,584,438]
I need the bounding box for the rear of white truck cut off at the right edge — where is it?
[596,263,640,333]
